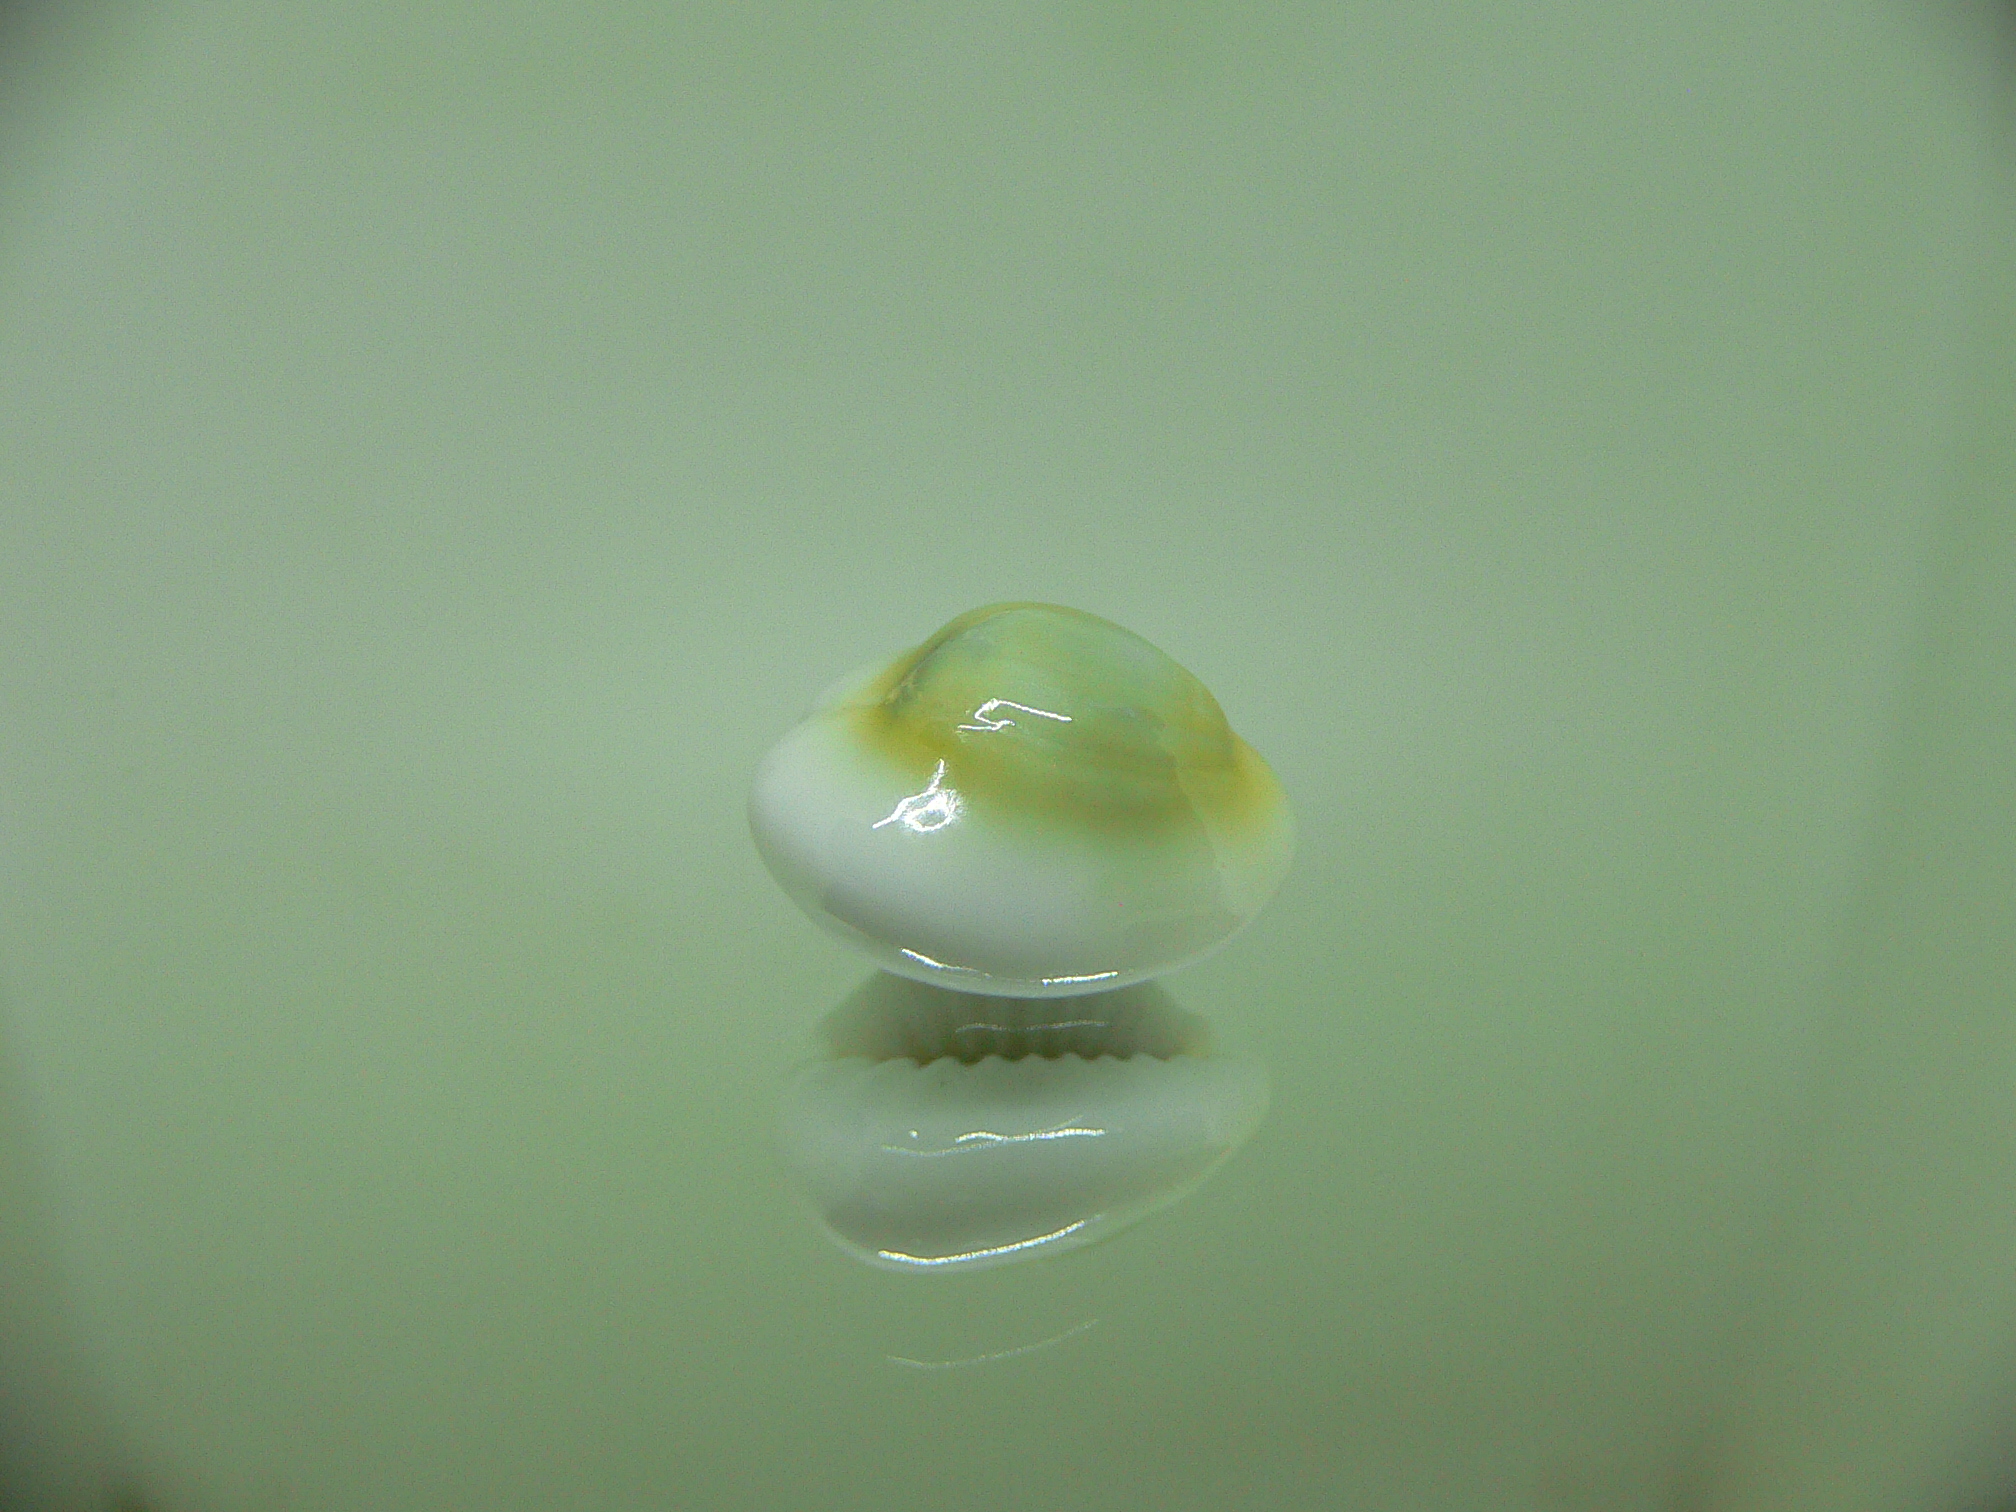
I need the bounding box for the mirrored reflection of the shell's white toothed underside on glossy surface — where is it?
[782,974,1268,1272]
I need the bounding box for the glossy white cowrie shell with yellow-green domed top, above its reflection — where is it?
[750,603,1294,996]
